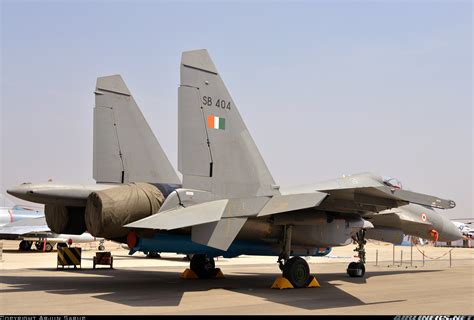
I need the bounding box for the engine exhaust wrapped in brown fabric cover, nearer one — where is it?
[84,183,165,239]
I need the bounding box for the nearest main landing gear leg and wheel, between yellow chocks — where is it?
[277,226,312,288]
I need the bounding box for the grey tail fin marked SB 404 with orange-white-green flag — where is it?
[178,50,279,198]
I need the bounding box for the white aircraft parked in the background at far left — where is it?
[0,195,105,252]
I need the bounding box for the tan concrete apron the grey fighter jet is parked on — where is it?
[0,241,474,315]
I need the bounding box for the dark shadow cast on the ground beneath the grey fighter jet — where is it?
[0,269,433,310]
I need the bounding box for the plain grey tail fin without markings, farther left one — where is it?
[93,75,180,184]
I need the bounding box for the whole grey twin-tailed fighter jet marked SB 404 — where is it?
[8,50,458,287]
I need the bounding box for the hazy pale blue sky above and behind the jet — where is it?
[0,1,473,218]
